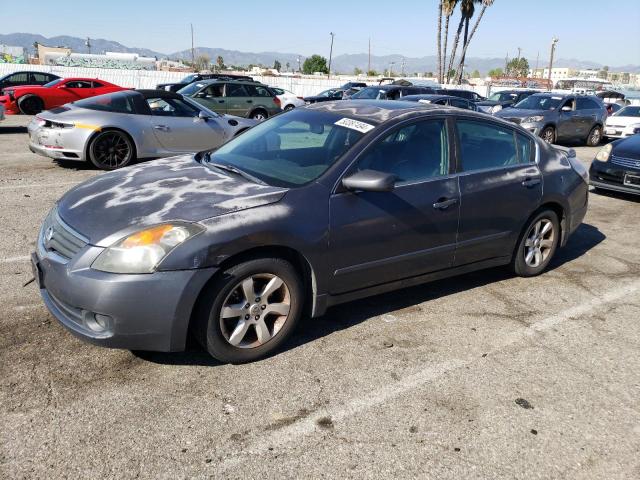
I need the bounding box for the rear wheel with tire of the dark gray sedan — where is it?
[511,210,561,277]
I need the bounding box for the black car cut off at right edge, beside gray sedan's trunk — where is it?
[589,133,640,195]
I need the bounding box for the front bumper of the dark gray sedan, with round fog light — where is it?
[32,240,216,351]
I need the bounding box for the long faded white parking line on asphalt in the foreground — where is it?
[219,280,640,471]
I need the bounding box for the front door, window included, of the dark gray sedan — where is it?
[329,119,460,294]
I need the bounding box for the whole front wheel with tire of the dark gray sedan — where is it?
[194,258,304,364]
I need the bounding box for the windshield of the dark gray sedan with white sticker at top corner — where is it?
[206,109,373,188]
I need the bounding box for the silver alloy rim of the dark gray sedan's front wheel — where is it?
[220,273,291,348]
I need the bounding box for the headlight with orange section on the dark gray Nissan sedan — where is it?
[91,223,204,273]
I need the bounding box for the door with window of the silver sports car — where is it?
[147,98,225,153]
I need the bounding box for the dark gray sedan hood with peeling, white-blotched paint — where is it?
[58,155,287,247]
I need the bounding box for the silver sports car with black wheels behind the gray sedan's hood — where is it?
[29,90,257,170]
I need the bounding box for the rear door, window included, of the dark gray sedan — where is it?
[455,118,542,266]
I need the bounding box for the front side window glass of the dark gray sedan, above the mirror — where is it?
[358,120,449,183]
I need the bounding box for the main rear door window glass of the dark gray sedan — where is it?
[456,120,519,172]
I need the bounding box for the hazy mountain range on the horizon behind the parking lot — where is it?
[0,33,640,74]
